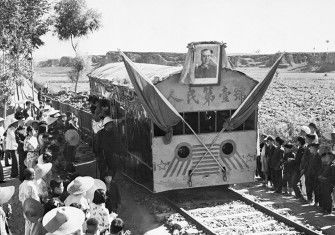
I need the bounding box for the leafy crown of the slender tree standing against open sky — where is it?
[55,0,101,52]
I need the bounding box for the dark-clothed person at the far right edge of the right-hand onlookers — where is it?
[318,152,335,214]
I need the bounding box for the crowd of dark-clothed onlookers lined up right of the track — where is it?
[257,123,335,214]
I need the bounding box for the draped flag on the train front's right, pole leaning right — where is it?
[227,54,284,130]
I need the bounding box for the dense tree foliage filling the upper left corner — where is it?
[0,0,52,108]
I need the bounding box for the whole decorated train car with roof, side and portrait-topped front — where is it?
[89,42,280,192]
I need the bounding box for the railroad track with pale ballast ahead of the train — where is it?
[122,173,320,235]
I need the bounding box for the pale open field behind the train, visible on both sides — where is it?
[35,67,335,138]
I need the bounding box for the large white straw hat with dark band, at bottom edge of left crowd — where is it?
[42,206,85,235]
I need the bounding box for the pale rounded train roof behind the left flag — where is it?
[88,62,183,88]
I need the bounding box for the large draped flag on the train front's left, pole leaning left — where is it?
[120,52,183,133]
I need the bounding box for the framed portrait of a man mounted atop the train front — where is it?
[191,44,221,85]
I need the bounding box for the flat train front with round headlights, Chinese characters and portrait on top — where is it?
[152,42,258,192]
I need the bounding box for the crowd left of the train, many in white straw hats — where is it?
[0,100,130,235]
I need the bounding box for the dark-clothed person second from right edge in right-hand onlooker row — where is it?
[305,143,322,205]
